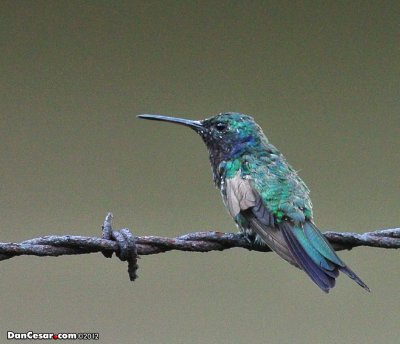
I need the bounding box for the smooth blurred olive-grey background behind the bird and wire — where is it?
[0,1,400,343]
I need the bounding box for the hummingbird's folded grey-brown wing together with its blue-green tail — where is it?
[226,173,368,292]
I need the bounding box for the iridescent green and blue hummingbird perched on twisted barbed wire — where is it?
[138,112,369,293]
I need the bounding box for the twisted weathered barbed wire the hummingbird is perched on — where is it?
[0,213,400,281]
